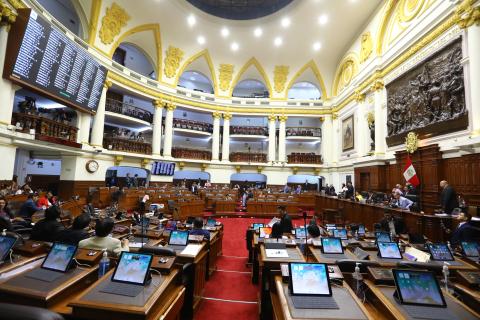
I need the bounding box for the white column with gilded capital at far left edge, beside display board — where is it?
[0,5,17,126]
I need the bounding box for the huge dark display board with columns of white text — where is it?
[4,9,107,111]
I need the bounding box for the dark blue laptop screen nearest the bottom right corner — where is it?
[392,269,447,307]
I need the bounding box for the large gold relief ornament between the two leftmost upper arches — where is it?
[99,2,130,45]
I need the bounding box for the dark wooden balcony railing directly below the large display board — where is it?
[12,113,81,148]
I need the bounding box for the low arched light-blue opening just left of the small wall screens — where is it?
[105,166,150,188]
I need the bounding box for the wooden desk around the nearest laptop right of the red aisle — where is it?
[270,276,378,320]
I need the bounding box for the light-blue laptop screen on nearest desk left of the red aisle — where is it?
[112,251,153,285]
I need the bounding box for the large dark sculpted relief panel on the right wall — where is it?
[387,39,468,146]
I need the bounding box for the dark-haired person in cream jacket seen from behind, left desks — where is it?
[78,218,128,256]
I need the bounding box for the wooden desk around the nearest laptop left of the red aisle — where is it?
[69,269,185,320]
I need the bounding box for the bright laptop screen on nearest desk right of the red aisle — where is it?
[289,263,332,296]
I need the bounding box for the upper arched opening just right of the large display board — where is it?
[112,42,157,79]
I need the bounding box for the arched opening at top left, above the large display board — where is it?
[38,0,86,39]
